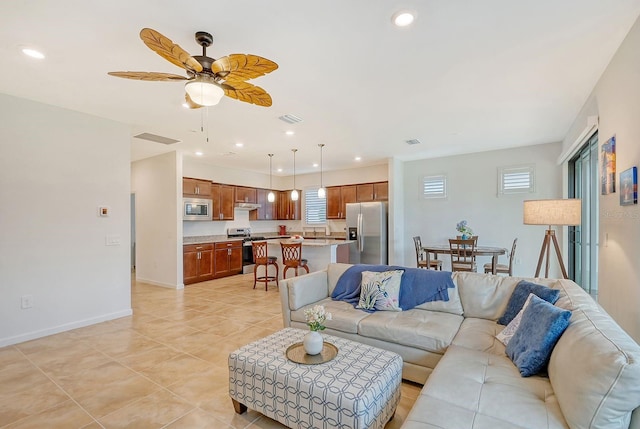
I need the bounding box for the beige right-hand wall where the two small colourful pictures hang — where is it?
[563,15,640,341]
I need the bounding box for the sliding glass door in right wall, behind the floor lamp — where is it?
[569,132,599,297]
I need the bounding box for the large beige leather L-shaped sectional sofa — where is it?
[280,264,640,429]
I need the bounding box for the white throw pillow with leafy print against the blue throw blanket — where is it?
[356,270,404,311]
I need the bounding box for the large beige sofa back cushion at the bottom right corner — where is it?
[548,308,640,429]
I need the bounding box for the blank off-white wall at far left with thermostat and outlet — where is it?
[0,94,131,347]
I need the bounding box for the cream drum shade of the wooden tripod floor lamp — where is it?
[523,199,582,225]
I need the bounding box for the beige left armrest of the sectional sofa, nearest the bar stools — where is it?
[279,270,329,328]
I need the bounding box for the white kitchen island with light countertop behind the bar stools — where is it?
[267,239,356,278]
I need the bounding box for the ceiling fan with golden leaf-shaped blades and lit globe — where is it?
[108,28,278,109]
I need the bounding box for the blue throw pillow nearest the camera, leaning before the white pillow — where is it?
[507,296,571,377]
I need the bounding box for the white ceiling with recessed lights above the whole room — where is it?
[0,0,640,175]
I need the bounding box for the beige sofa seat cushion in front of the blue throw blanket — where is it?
[358,308,463,353]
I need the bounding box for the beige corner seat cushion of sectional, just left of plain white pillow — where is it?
[451,317,505,356]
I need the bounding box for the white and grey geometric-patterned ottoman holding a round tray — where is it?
[229,328,402,429]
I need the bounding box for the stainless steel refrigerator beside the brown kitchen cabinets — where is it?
[347,202,388,265]
